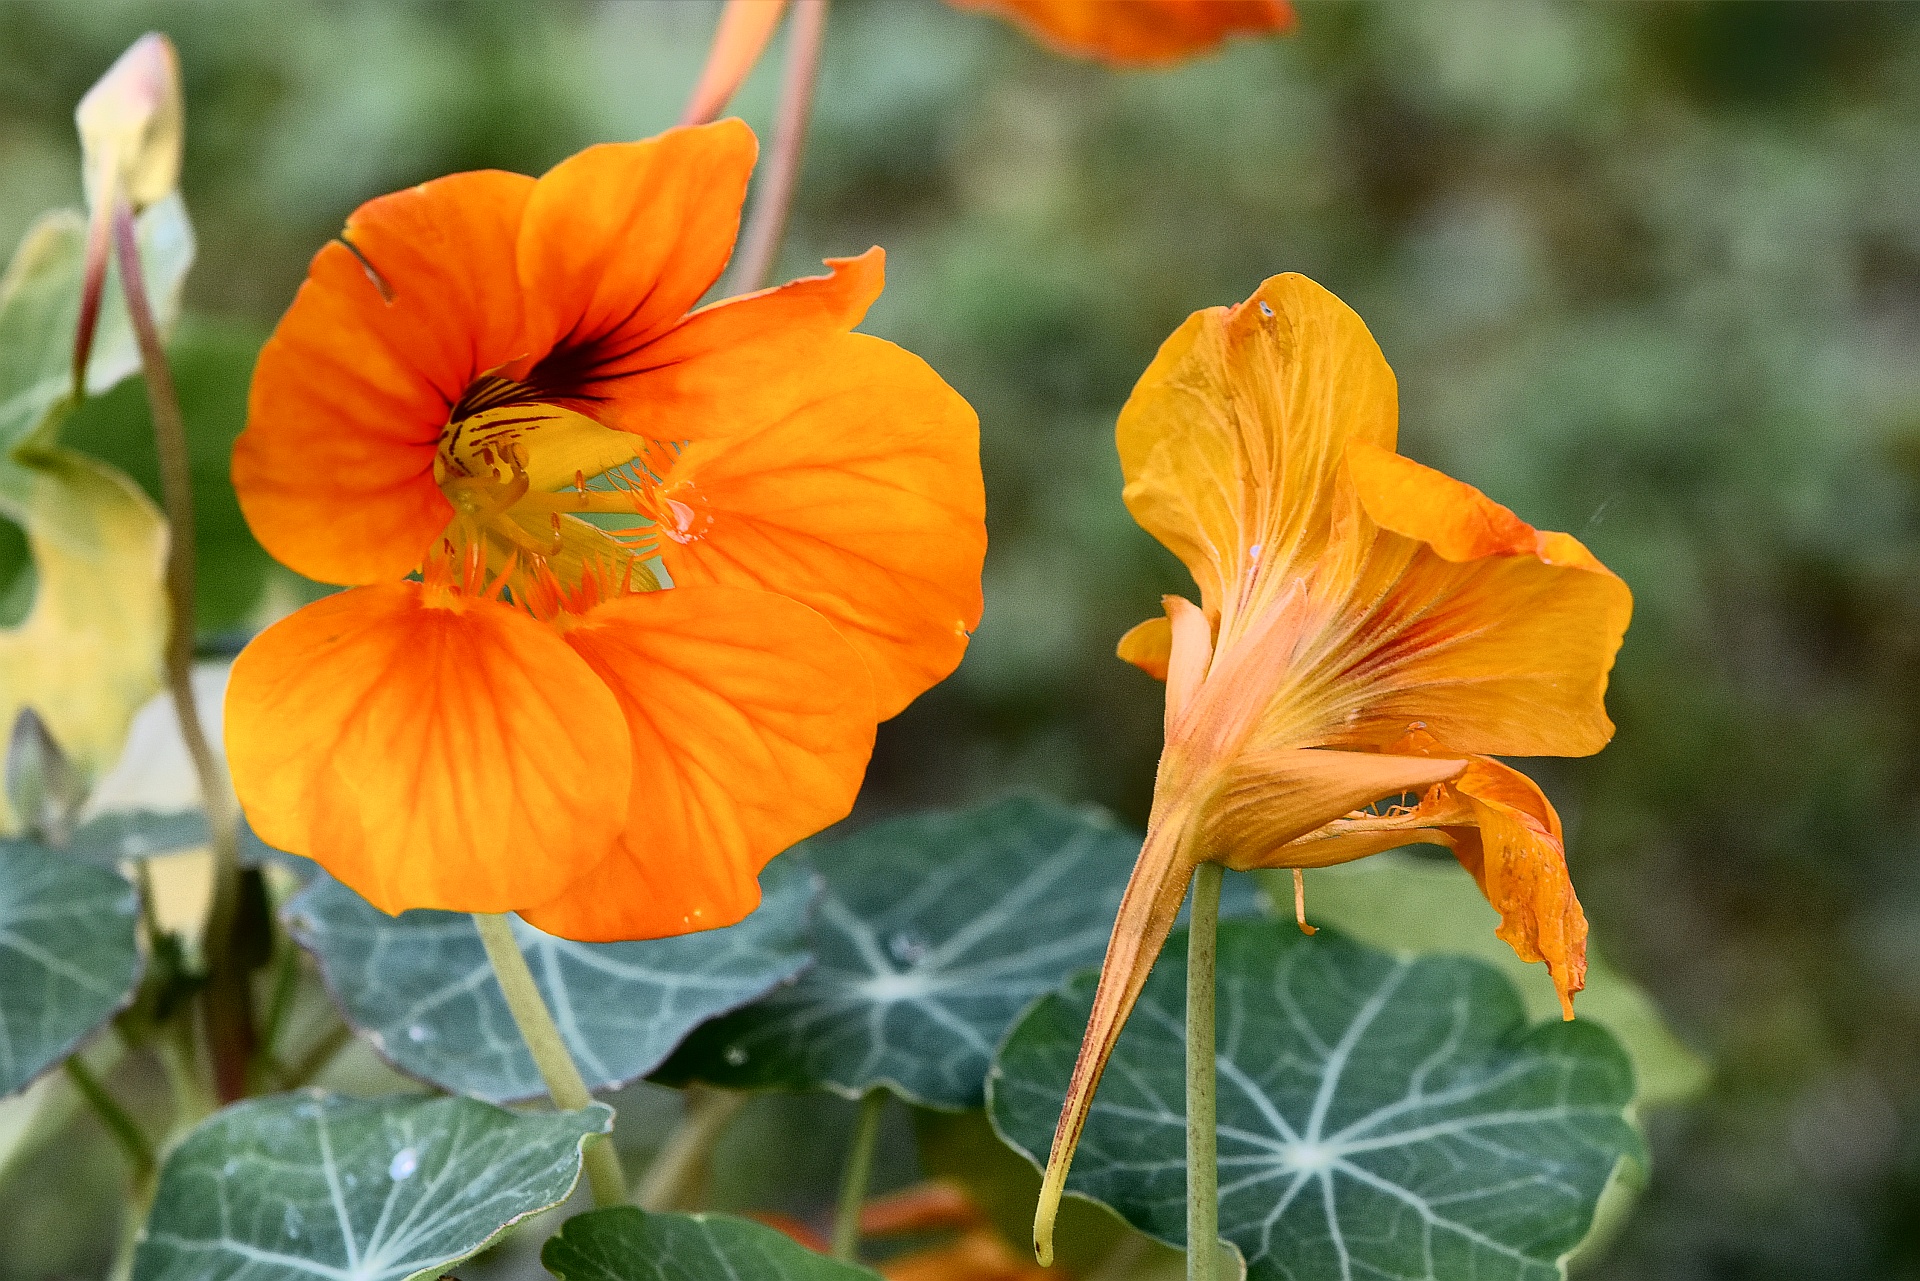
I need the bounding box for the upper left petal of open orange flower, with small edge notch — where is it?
[232,171,534,584]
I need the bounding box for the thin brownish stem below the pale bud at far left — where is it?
[111,198,253,1102]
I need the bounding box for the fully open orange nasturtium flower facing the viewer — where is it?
[227,121,987,939]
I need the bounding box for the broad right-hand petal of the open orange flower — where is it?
[662,334,987,718]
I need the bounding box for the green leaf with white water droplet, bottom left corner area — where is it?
[132,1091,612,1281]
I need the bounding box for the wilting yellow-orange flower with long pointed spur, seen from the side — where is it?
[1035,275,1632,1262]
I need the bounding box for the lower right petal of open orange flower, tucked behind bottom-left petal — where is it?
[522,588,874,941]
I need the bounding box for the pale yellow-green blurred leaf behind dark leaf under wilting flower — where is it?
[1290,855,1707,1108]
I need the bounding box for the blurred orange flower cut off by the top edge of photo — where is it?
[952,0,1296,65]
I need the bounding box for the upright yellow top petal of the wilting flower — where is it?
[1117,275,1400,643]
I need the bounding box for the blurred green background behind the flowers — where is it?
[0,0,1920,1279]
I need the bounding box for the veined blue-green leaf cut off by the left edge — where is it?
[0,841,140,1095]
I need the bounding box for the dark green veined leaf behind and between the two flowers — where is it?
[660,797,1260,1108]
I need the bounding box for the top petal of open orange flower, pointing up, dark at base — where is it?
[518,119,758,430]
